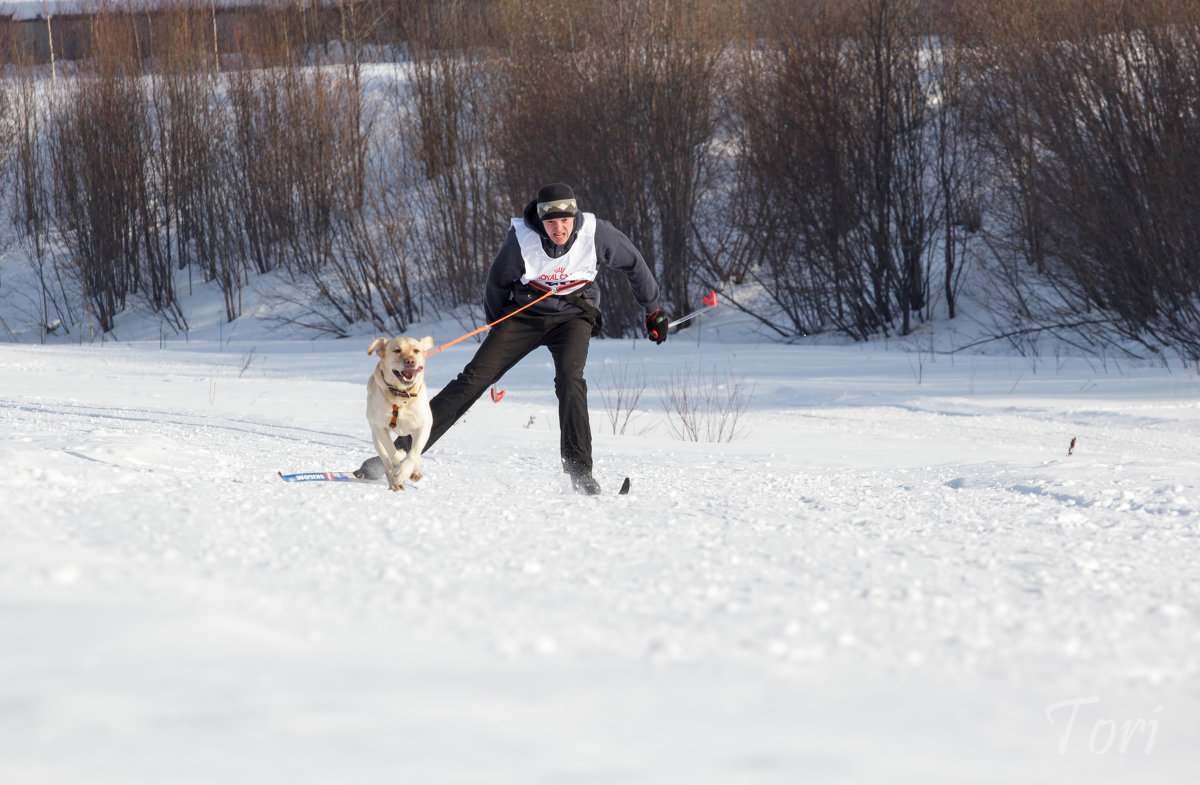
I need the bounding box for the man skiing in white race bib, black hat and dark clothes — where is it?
[354,182,668,495]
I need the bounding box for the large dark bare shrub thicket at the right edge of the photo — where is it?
[982,0,1200,359]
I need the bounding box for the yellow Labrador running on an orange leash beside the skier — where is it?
[367,336,433,491]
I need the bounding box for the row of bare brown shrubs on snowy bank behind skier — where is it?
[0,0,1200,358]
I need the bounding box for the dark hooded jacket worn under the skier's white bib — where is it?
[484,202,659,322]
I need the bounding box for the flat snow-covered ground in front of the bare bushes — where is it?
[0,285,1200,785]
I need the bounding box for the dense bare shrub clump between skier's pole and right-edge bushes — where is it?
[737,0,956,340]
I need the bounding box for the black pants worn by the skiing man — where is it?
[425,313,592,474]
